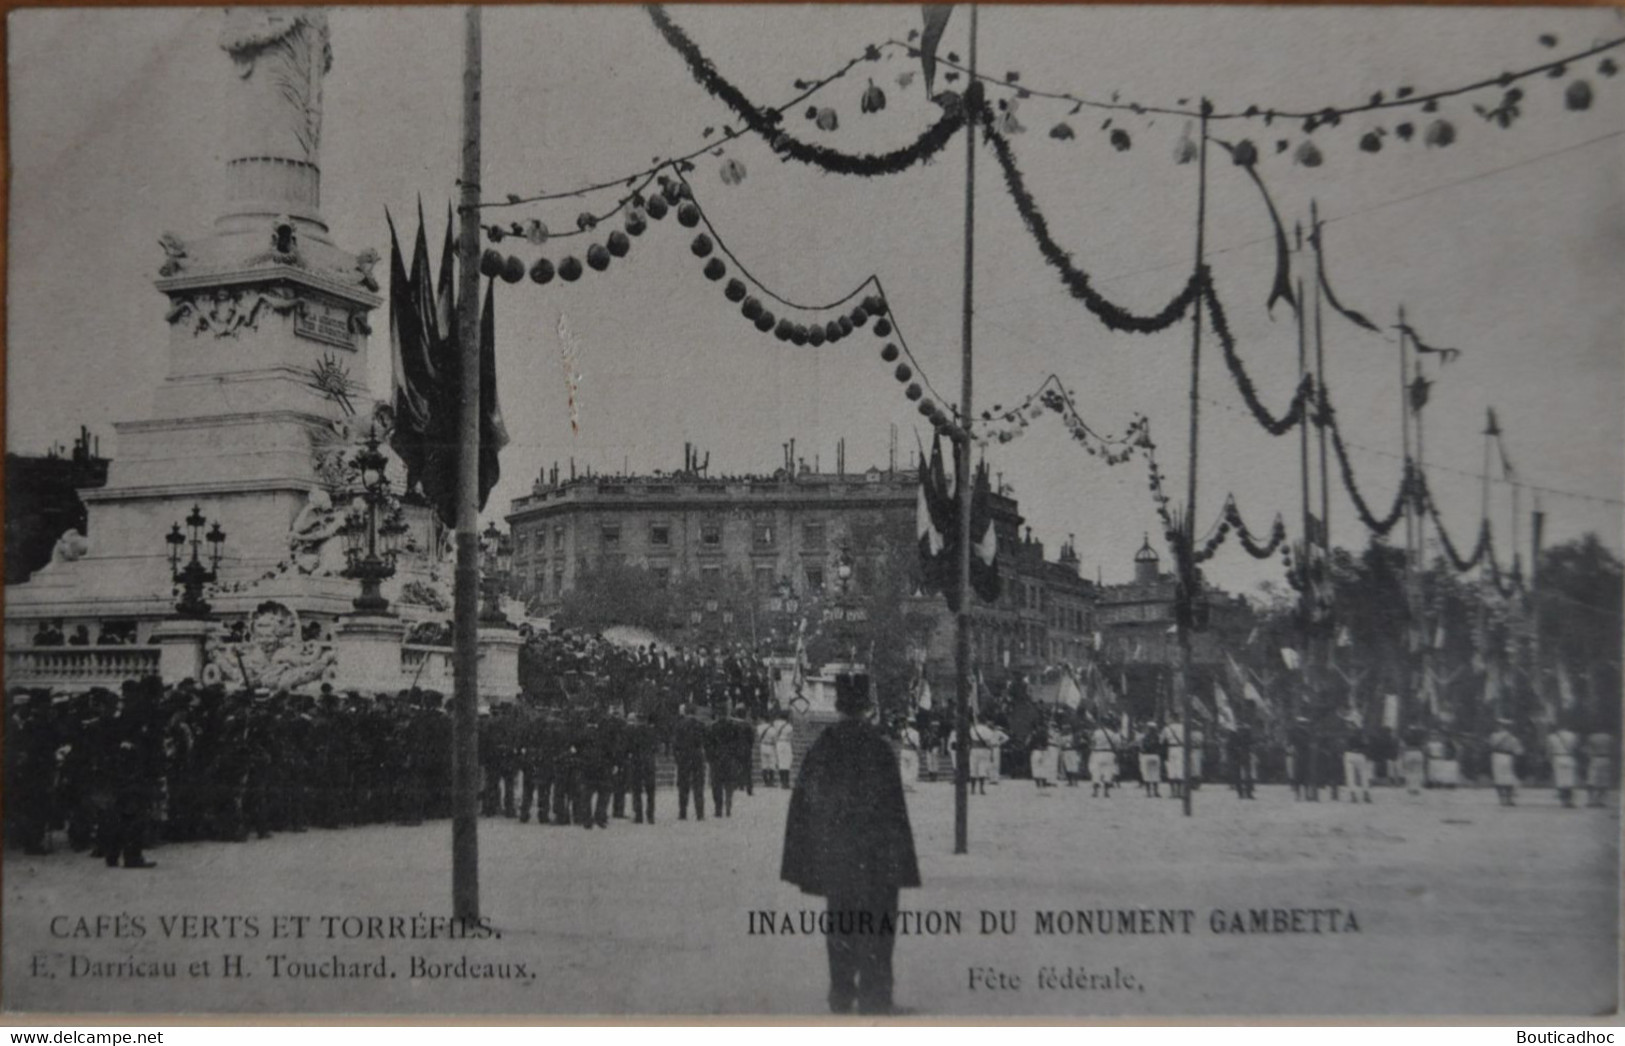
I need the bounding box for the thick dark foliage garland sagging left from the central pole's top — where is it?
[644,3,967,177]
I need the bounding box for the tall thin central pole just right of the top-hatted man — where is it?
[954,3,980,853]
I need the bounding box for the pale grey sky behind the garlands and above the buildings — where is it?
[7,5,1625,590]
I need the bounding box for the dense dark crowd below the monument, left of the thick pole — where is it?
[5,679,484,867]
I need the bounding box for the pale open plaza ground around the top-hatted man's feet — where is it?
[3,781,1620,1017]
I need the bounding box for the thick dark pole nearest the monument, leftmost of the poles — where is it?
[452,5,481,919]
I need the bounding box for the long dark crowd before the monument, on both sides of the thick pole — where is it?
[5,659,795,869]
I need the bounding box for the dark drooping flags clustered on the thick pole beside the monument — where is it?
[385,208,509,528]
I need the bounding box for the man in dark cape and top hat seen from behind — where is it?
[778,674,920,1014]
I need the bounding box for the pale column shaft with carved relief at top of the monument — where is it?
[219,8,333,166]
